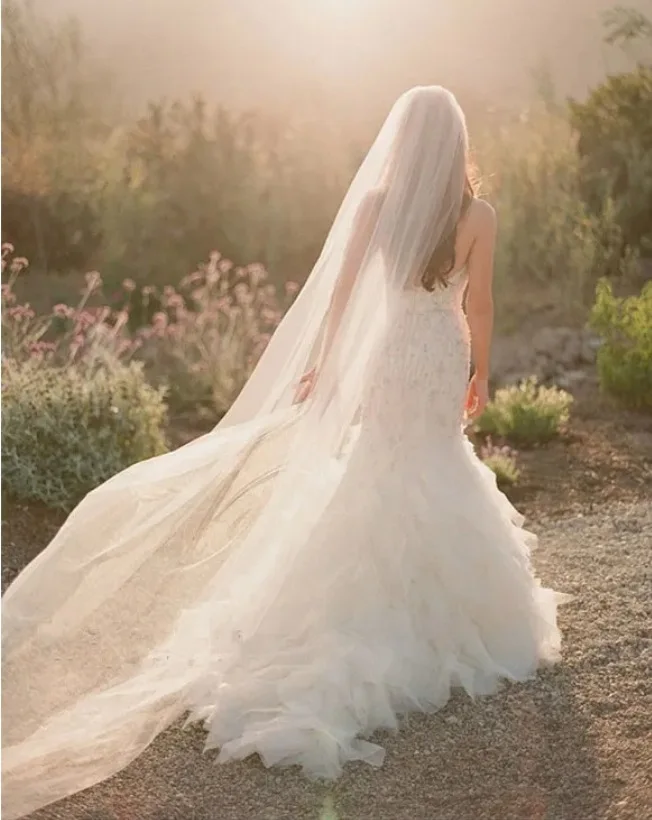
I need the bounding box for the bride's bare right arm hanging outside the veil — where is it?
[466,201,496,382]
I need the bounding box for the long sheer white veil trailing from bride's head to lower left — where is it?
[2,87,466,820]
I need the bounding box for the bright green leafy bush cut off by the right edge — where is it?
[590,281,652,410]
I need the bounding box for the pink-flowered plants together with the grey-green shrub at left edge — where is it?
[2,245,166,509]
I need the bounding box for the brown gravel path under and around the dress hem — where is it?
[24,502,652,820]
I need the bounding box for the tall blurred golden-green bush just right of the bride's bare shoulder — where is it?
[475,107,625,326]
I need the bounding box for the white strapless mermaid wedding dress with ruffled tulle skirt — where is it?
[182,271,561,777]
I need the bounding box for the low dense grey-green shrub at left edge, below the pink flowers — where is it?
[2,359,165,510]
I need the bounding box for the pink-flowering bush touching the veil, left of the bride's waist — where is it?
[137,253,298,418]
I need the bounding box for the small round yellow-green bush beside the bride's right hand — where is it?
[476,378,573,446]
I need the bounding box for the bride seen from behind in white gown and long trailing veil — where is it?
[2,87,564,820]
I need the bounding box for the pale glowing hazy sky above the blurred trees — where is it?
[35,0,652,113]
